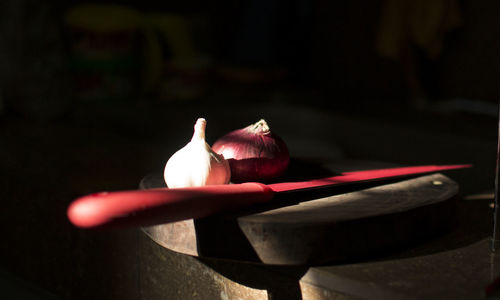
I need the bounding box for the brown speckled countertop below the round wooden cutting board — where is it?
[138,192,500,300]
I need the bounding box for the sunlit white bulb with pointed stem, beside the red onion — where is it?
[163,118,231,188]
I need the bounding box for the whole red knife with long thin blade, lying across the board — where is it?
[67,165,471,228]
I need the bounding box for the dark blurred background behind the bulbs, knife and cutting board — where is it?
[0,0,500,299]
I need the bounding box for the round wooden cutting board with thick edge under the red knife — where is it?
[140,161,458,265]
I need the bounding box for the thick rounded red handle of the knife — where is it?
[67,182,274,228]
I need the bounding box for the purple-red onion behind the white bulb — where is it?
[212,119,290,182]
